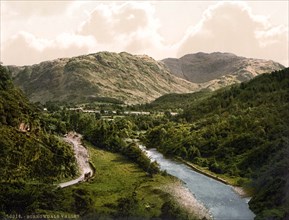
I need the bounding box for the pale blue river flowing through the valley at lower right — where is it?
[140,145,255,220]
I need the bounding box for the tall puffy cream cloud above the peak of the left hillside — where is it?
[78,2,162,53]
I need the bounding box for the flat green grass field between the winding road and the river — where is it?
[59,143,186,218]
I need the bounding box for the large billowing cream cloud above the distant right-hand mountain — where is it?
[178,2,288,65]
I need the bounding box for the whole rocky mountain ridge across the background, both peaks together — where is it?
[7,51,283,104]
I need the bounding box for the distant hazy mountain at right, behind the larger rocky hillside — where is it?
[162,52,284,90]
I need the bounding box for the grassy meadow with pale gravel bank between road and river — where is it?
[83,143,211,219]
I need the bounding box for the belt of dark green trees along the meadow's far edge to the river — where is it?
[51,110,159,175]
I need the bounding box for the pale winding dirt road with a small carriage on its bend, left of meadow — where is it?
[59,132,93,188]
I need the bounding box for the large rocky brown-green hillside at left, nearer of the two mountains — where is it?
[8,52,199,103]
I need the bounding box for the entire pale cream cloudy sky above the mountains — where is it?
[0,0,289,66]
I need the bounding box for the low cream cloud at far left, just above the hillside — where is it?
[1,32,95,65]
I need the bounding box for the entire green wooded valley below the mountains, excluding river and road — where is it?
[0,62,289,219]
